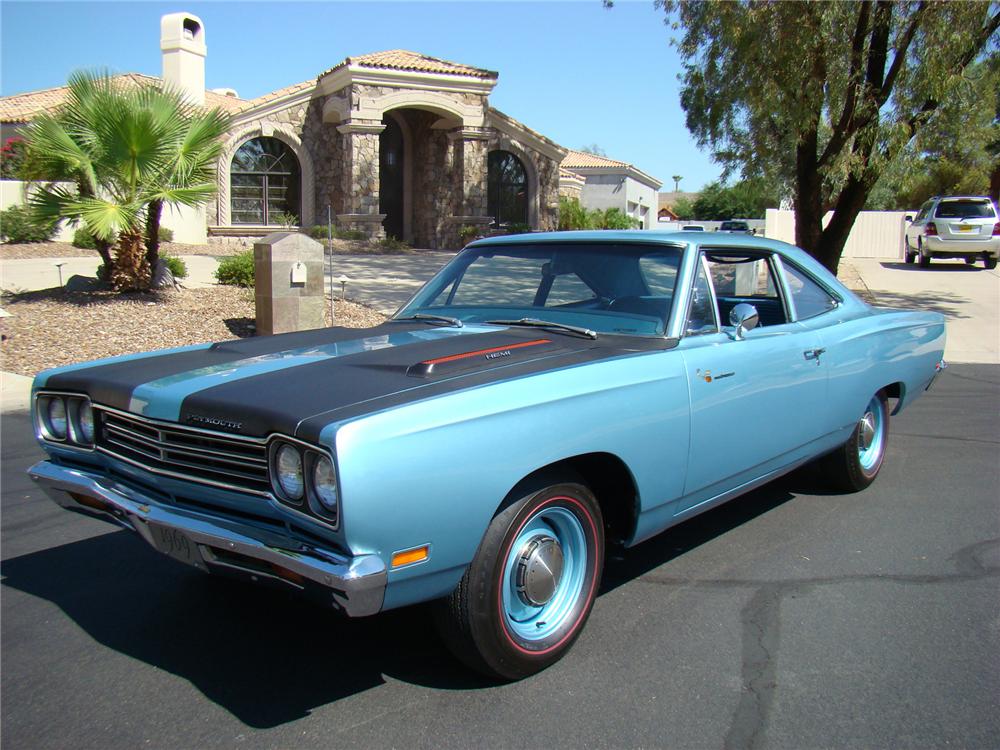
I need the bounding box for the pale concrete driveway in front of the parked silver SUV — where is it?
[847,258,1000,364]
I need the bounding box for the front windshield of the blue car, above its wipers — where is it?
[395,242,681,336]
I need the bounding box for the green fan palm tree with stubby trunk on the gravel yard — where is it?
[26,73,229,290]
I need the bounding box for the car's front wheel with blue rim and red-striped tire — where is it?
[438,483,604,680]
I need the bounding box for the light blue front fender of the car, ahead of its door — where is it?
[322,352,689,608]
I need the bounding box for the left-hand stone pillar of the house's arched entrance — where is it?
[337,120,385,239]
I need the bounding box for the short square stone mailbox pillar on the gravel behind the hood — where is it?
[253,232,326,336]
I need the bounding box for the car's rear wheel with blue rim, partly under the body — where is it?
[821,391,889,492]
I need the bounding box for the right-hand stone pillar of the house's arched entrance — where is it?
[448,127,493,247]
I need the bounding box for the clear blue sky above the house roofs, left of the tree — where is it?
[0,0,720,191]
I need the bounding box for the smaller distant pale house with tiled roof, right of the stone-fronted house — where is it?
[561,150,663,229]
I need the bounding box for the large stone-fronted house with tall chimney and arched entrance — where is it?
[0,13,580,248]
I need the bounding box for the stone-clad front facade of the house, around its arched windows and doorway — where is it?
[208,53,566,248]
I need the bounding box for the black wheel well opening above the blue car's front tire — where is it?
[508,453,639,544]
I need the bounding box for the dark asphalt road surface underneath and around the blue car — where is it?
[0,365,1000,750]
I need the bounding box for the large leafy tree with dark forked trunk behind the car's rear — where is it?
[657,0,1000,271]
